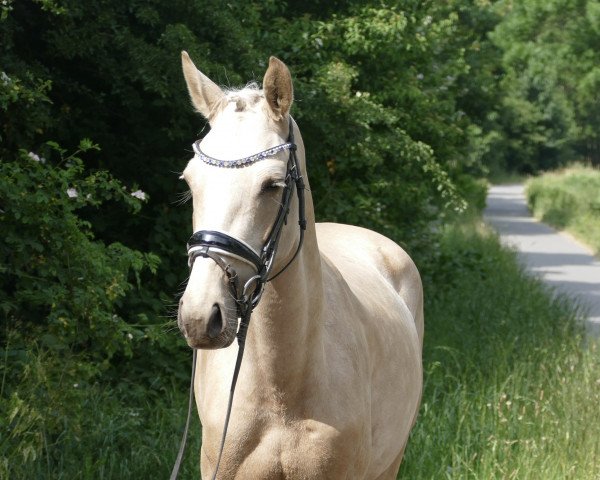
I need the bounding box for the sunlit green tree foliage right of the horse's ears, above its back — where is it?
[265,4,476,251]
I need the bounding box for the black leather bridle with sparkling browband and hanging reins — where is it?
[170,117,306,480]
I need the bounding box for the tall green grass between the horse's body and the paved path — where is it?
[398,219,600,480]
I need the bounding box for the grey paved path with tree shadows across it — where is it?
[484,185,600,335]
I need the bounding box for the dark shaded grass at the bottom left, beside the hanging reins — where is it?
[0,354,200,480]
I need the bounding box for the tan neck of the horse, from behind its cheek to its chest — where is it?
[245,181,323,398]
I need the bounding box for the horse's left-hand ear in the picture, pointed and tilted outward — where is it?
[181,50,225,121]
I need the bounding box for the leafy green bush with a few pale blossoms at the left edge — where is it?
[0,140,158,362]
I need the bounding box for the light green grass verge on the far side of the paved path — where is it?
[527,166,600,254]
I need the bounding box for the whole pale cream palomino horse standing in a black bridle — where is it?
[178,52,423,480]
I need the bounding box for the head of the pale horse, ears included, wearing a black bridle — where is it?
[178,52,301,349]
